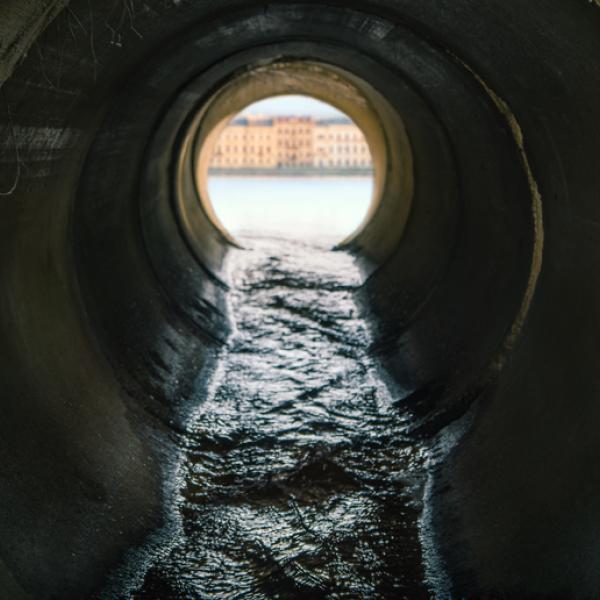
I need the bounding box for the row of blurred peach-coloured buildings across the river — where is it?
[211,116,372,171]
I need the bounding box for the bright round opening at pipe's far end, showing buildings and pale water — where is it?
[200,95,373,246]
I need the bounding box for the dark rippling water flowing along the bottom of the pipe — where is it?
[133,239,429,600]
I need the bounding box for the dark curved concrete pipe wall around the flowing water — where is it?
[0,0,600,598]
